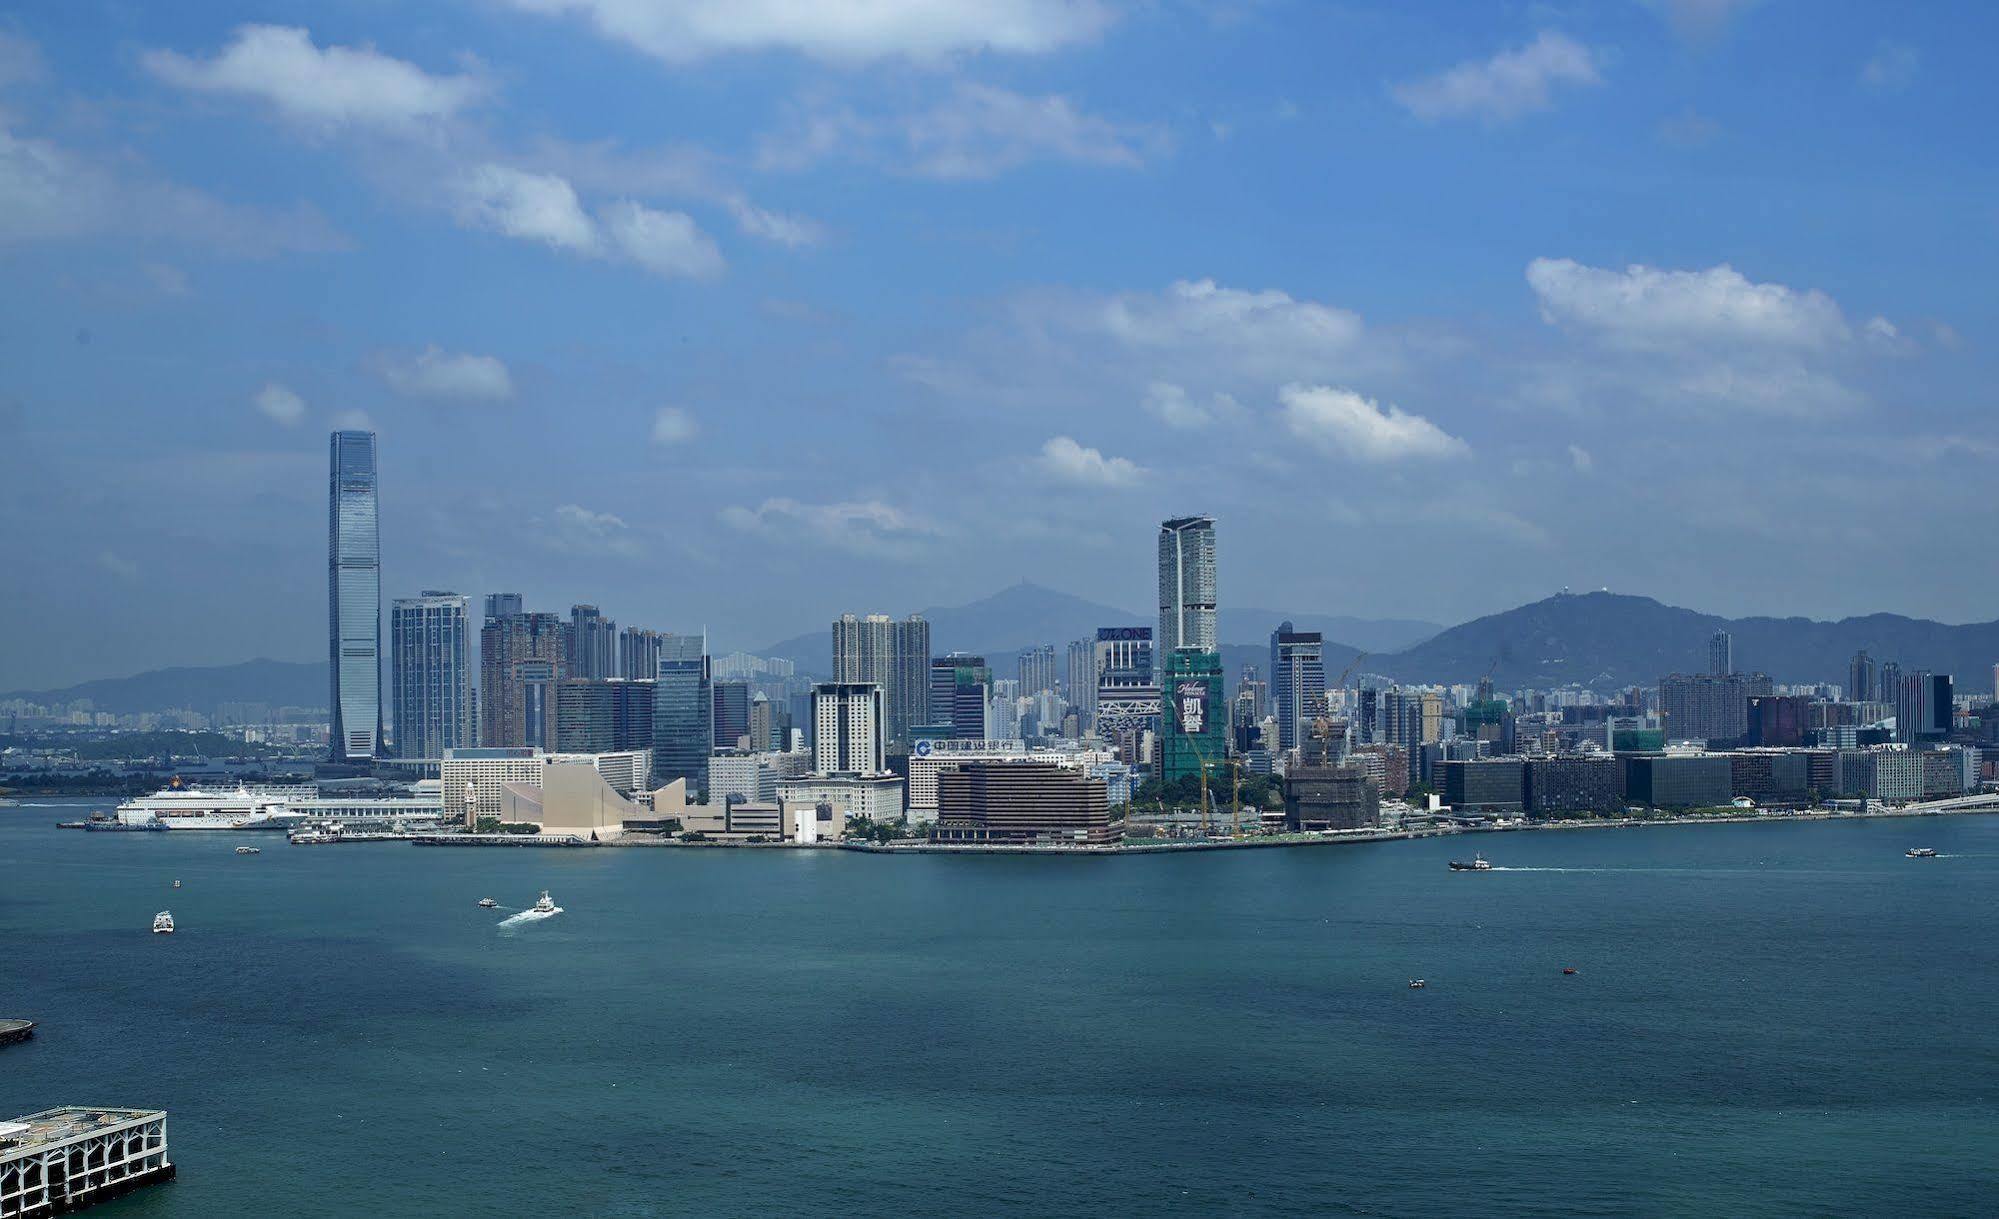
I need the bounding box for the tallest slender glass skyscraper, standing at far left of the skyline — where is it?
[326,432,382,761]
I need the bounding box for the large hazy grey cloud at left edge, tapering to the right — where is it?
[0,116,348,258]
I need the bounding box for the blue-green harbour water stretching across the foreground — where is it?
[0,791,1999,1217]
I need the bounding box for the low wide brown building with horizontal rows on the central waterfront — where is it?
[930,761,1123,845]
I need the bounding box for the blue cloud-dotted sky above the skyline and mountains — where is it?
[0,0,1999,689]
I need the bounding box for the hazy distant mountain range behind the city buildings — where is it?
[15,584,1999,713]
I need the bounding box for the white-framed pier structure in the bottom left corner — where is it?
[0,1105,174,1219]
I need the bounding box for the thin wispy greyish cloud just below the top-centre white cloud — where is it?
[758,82,1169,180]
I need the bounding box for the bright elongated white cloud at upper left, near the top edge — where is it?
[140,26,488,130]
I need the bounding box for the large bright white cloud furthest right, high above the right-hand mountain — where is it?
[1527,258,1851,350]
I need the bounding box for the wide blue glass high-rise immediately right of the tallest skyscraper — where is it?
[390,592,478,757]
